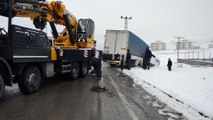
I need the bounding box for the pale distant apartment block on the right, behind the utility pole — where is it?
[176,40,192,50]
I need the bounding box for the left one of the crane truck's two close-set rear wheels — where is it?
[70,62,79,80]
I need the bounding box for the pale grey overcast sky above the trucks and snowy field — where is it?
[0,0,213,49]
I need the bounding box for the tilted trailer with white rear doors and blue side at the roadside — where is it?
[103,30,148,65]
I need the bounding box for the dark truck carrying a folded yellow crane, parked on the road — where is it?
[0,0,102,99]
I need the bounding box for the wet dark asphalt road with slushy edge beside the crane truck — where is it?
[0,64,185,120]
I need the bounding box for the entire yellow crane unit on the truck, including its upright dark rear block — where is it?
[0,0,96,48]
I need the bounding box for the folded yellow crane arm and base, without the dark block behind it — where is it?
[14,1,78,48]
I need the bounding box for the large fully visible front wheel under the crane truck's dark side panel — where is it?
[18,66,41,94]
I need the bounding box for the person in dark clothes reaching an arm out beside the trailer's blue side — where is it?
[143,47,155,70]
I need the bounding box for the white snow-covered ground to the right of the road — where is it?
[124,51,213,120]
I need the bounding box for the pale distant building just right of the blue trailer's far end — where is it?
[151,40,166,51]
